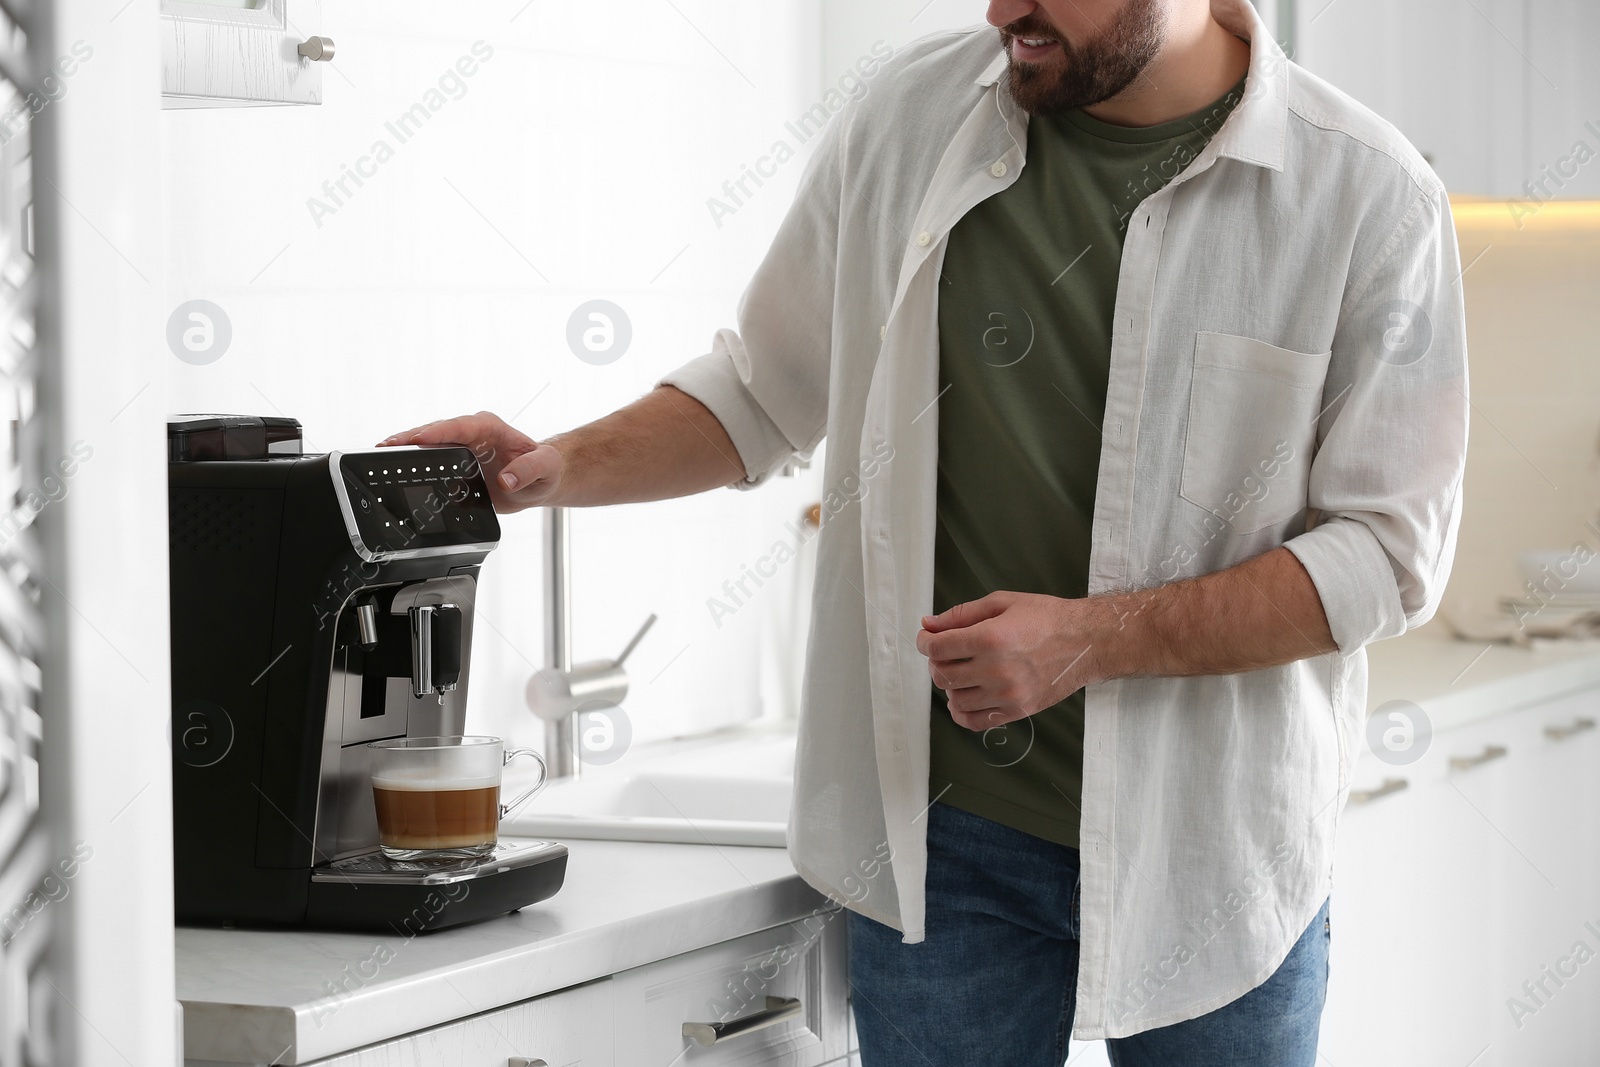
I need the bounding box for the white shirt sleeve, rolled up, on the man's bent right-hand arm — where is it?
[1288,189,1469,653]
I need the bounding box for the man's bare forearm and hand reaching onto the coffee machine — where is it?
[381,386,746,512]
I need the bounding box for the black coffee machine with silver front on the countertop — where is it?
[168,416,566,934]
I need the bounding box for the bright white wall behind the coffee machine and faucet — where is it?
[162,0,838,744]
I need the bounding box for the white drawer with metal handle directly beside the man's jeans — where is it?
[613,910,850,1067]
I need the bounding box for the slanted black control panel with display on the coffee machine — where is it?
[336,448,499,555]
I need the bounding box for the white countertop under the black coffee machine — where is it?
[178,841,822,1064]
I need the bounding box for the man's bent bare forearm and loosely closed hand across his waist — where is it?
[917,547,1336,729]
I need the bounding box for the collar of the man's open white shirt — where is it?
[978,0,1290,171]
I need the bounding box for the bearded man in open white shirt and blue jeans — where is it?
[387,0,1467,1067]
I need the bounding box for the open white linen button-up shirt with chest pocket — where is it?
[662,0,1467,1040]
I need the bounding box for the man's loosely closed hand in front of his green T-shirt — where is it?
[917,592,1115,729]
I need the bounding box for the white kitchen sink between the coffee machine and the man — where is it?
[501,733,795,848]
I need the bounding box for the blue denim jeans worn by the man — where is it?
[848,805,1330,1067]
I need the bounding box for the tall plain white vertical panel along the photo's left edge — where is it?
[40,0,178,1067]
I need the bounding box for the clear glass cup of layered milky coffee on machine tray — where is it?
[366,737,549,859]
